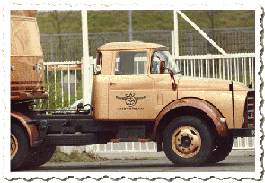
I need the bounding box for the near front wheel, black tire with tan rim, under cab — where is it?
[163,116,214,166]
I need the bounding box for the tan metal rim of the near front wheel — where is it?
[172,126,201,158]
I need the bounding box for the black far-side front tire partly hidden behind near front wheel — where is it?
[205,135,234,163]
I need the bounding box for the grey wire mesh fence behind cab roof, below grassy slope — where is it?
[41,27,255,62]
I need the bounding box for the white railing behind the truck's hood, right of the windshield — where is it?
[175,53,255,88]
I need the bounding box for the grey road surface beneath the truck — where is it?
[19,156,255,172]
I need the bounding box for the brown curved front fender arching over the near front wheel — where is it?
[153,98,228,139]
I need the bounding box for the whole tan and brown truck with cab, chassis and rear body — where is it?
[10,11,255,171]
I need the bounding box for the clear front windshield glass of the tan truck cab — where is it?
[151,50,180,74]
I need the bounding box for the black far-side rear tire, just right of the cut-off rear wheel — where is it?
[19,145,56,169]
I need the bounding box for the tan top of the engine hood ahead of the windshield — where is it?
[176,75,248,91]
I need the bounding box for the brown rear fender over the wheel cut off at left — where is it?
[11,112,39,147]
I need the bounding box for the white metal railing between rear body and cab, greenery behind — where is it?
[44,61,82,109]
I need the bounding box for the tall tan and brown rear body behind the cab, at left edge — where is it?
[10,10,48,101]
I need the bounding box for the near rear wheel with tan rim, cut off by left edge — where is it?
[11,124,29,171]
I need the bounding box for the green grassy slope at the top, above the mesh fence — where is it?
[37,10,255,34]
